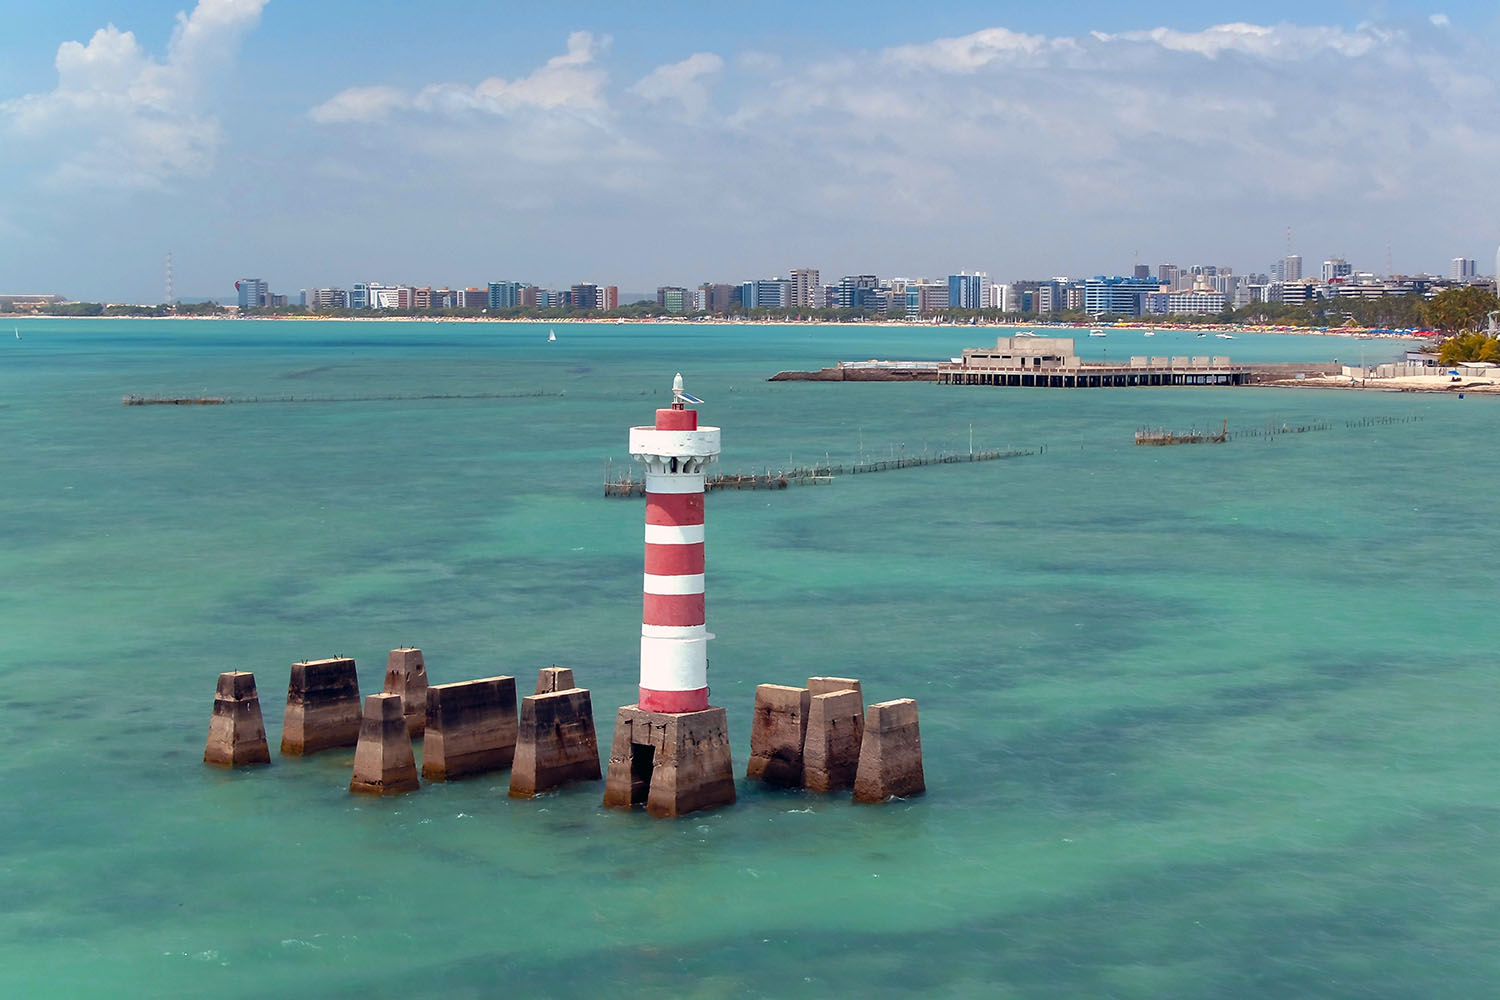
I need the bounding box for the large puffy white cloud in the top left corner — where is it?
[0,0,266,187]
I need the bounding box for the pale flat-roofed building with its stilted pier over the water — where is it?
[938,337,1251,388]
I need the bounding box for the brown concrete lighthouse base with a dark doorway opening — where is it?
[605,705,735,816]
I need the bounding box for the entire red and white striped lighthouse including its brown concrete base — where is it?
[605,373,735,816]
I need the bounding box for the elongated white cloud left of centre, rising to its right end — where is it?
[308,31,609,124]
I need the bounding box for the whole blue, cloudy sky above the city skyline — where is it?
[0,0,1500,303]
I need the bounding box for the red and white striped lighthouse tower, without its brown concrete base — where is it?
[630,373,719,714]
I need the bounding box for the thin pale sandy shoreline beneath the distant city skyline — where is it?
[0,312,1439,343]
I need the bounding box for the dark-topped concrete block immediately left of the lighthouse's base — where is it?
[510,688,603,799]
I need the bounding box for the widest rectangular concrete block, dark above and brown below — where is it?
[422,678,516,781]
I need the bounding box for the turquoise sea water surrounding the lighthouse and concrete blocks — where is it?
[0,321,1500,997]
